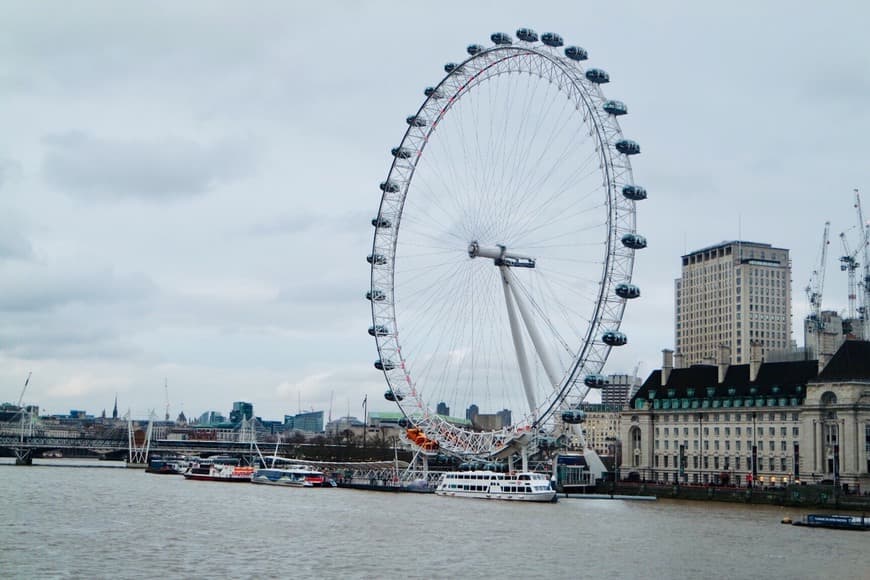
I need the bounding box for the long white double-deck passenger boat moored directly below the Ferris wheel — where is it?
[435,471,556,501]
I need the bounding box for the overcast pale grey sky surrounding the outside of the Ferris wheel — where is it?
[0,0,870,419]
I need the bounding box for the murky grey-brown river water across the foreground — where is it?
[0,460,870,580]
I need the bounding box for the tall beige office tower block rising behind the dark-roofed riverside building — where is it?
[674,241,791,366]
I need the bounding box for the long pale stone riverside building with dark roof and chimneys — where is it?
[620,341,870,489]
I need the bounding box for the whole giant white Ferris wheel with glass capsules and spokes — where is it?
[367,28,646,457]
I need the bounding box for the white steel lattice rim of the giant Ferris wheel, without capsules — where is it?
[370,32,635,454]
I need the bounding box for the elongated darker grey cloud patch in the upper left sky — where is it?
[43,132,253,201]
